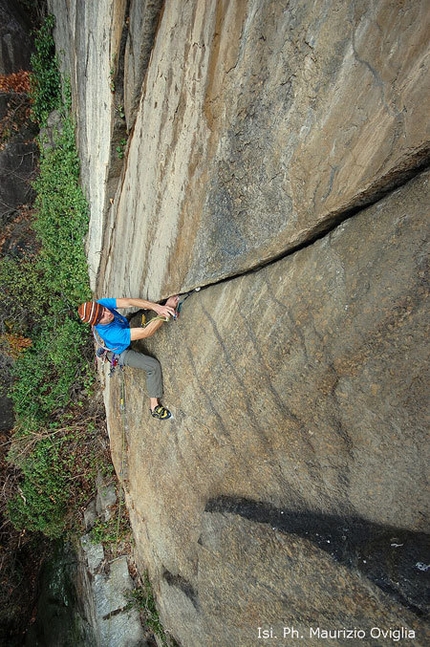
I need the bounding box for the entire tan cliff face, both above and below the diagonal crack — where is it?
[50,0,430,647]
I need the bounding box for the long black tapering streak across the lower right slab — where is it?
[205,497,430,616]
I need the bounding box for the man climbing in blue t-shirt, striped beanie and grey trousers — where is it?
[78,296,179,420]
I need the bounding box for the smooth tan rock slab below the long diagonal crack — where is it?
[106,173,430,645]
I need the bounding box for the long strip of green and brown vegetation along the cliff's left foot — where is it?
[0,16,110,538]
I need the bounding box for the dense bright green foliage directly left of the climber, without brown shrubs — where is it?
[9,111,91,431]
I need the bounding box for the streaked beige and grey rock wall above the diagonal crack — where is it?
[97,0,430,298]
